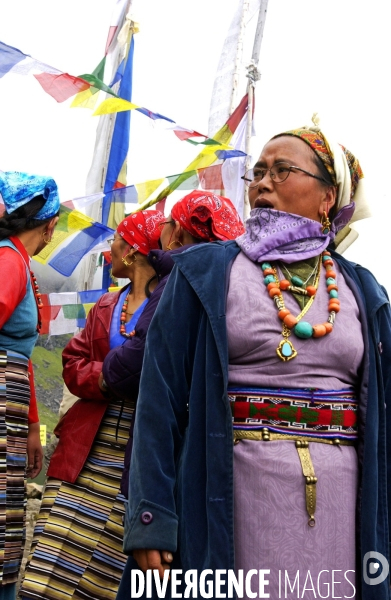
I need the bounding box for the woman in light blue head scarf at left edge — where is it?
[0,171,60,600]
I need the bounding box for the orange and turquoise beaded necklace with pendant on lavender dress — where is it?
[261,251,340,361]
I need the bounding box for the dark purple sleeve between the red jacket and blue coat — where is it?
[102,279,167,399]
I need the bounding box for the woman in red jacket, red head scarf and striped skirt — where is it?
[19,210,164,600]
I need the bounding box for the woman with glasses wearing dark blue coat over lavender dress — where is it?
[118,129,391,600]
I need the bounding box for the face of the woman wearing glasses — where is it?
[249,136,335,221]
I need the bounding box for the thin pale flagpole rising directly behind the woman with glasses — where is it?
[244,0,269,220]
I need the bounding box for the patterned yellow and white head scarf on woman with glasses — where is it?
[272,118,371,253]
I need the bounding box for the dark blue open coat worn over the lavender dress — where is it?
[118,242,391,600]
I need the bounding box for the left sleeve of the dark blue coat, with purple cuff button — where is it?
[124,267,202,554]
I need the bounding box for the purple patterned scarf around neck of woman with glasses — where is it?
[236,202,355,264]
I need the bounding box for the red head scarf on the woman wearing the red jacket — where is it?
[117,210,165,255]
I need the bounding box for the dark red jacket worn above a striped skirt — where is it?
[48,291,121,483]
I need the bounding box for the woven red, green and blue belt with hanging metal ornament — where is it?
[228,388,357,527]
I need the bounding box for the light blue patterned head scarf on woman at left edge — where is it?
[0,171,60,221]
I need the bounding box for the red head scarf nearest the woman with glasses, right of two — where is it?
[171,190,245,242]
